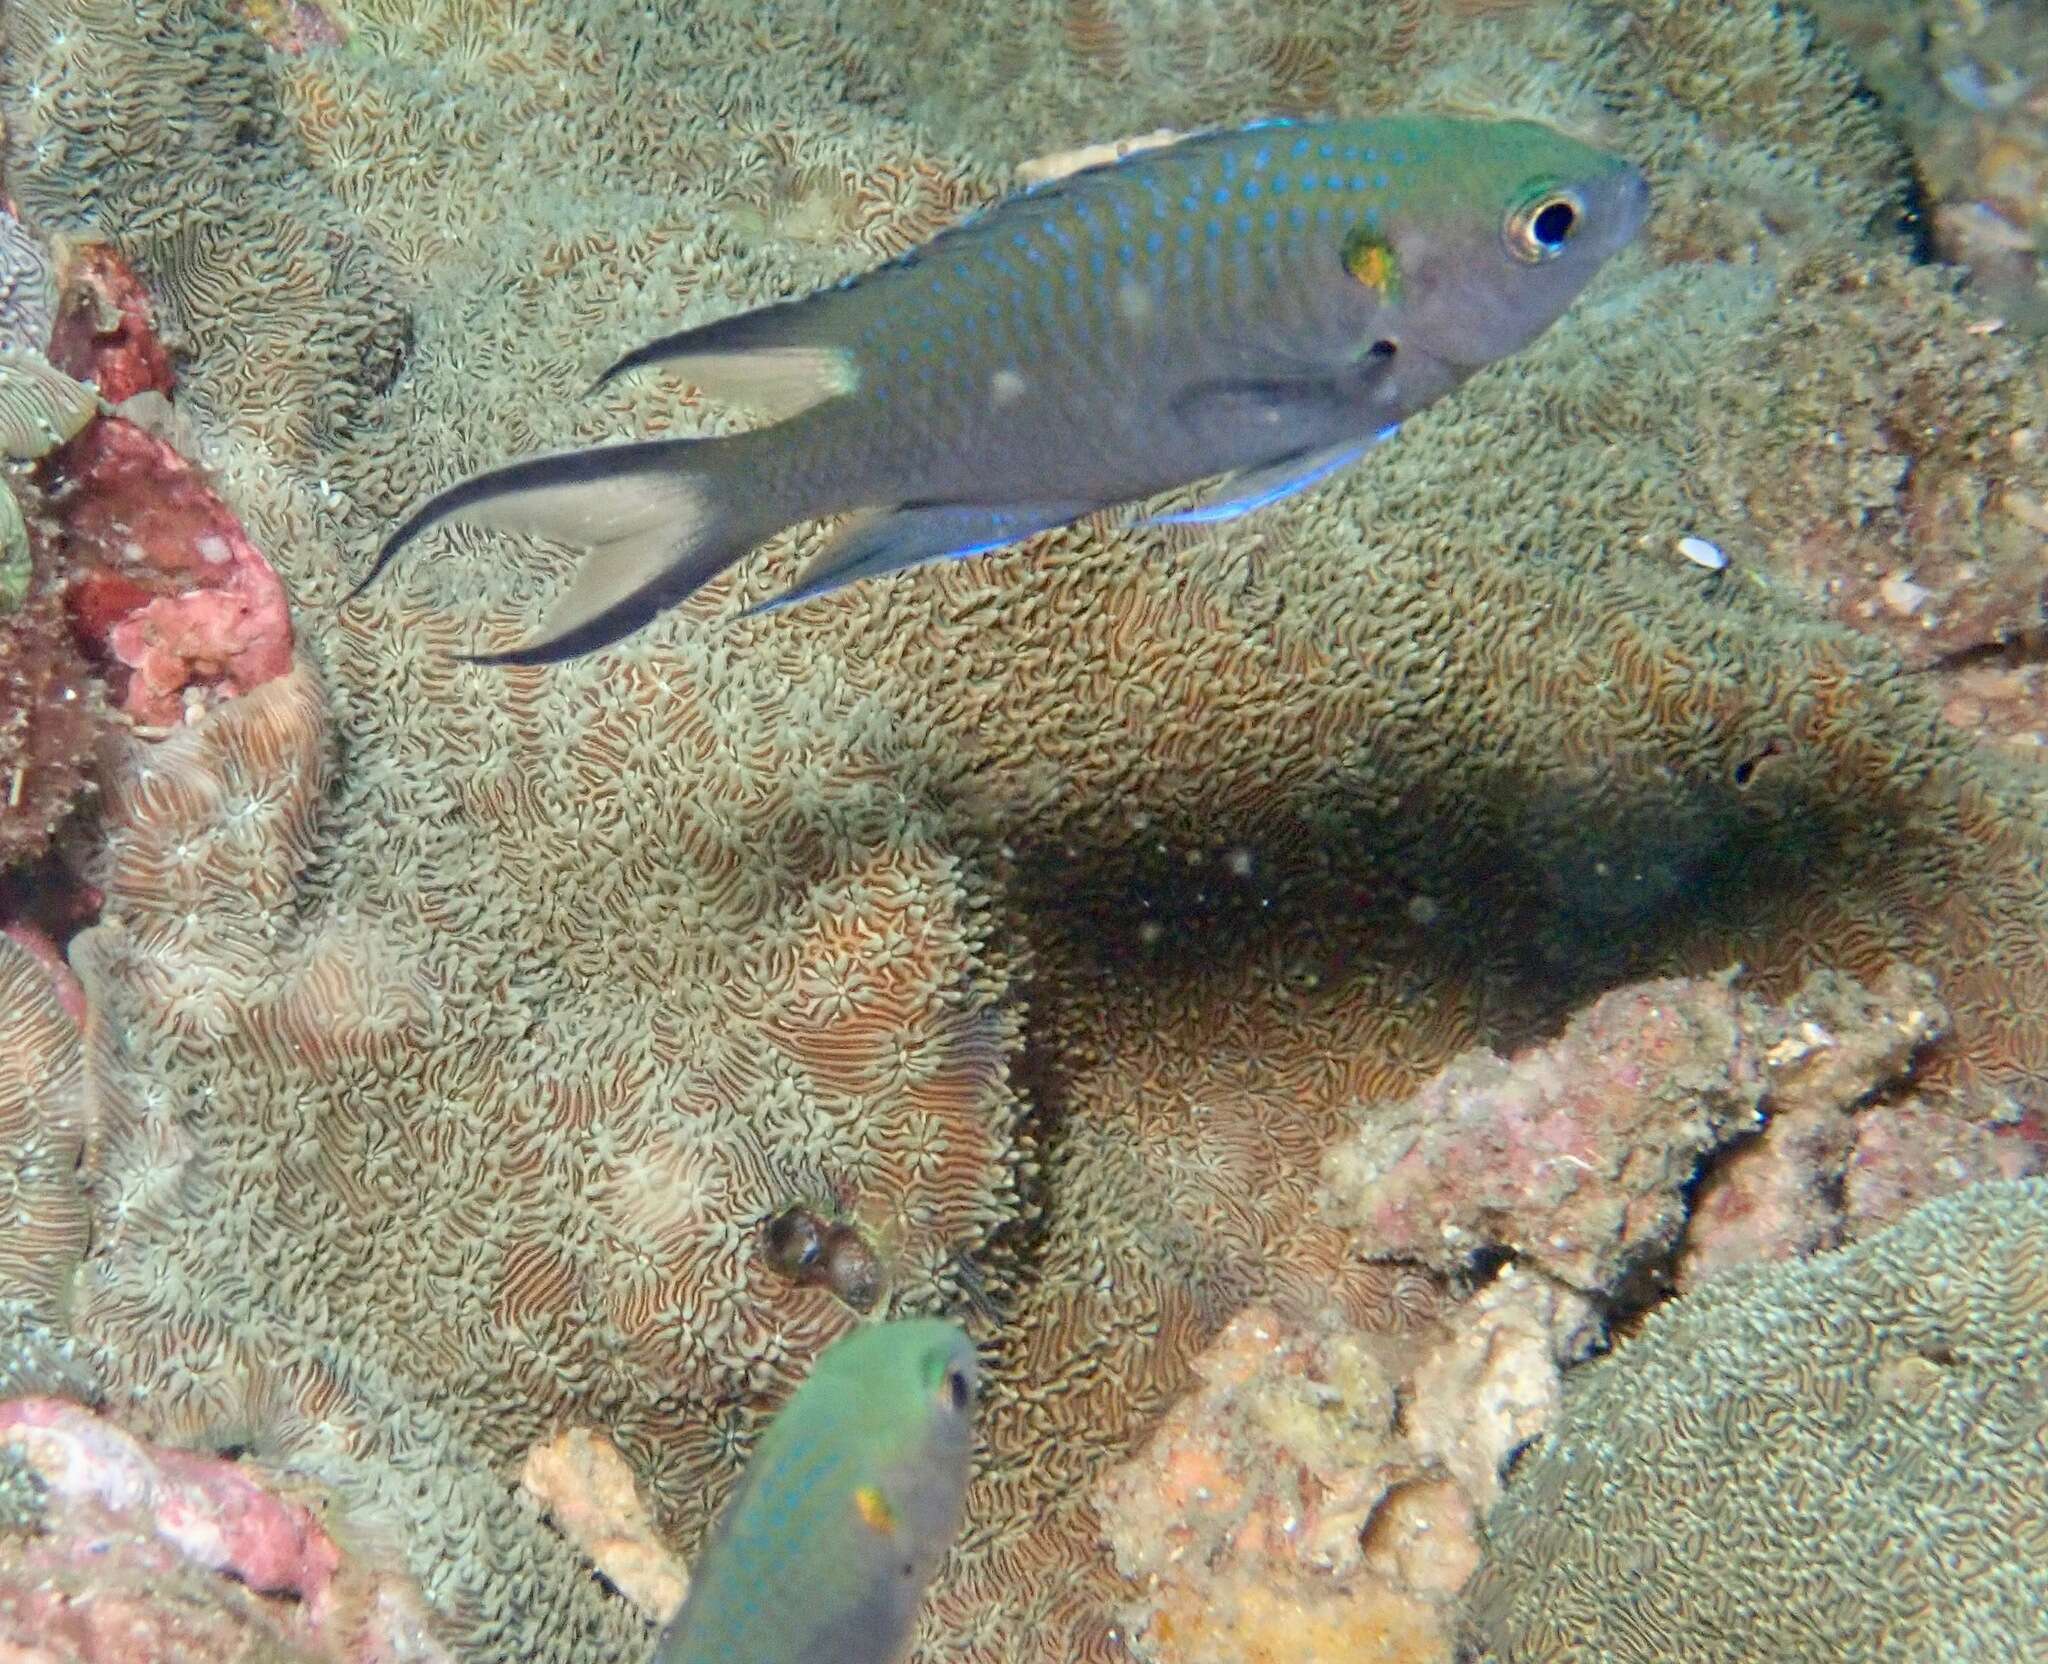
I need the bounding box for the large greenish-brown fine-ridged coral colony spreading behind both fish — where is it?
[4,0,2048,1660]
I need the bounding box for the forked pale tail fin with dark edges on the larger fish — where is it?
[344,432,786,664]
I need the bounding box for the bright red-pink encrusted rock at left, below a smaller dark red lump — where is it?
[51,416,291,725]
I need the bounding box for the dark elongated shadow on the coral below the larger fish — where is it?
[1018,748,1884,1092]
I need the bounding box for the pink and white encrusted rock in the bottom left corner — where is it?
[0,1398,449,1664]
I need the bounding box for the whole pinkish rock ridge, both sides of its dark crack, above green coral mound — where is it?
[1325,963,2023,1297]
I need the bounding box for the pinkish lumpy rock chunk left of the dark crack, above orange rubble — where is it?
[1323,975,1763,1291]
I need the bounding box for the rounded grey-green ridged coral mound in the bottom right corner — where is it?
[1470,1178,2048,1664]
